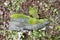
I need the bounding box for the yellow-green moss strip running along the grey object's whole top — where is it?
[11,14,48,24]
